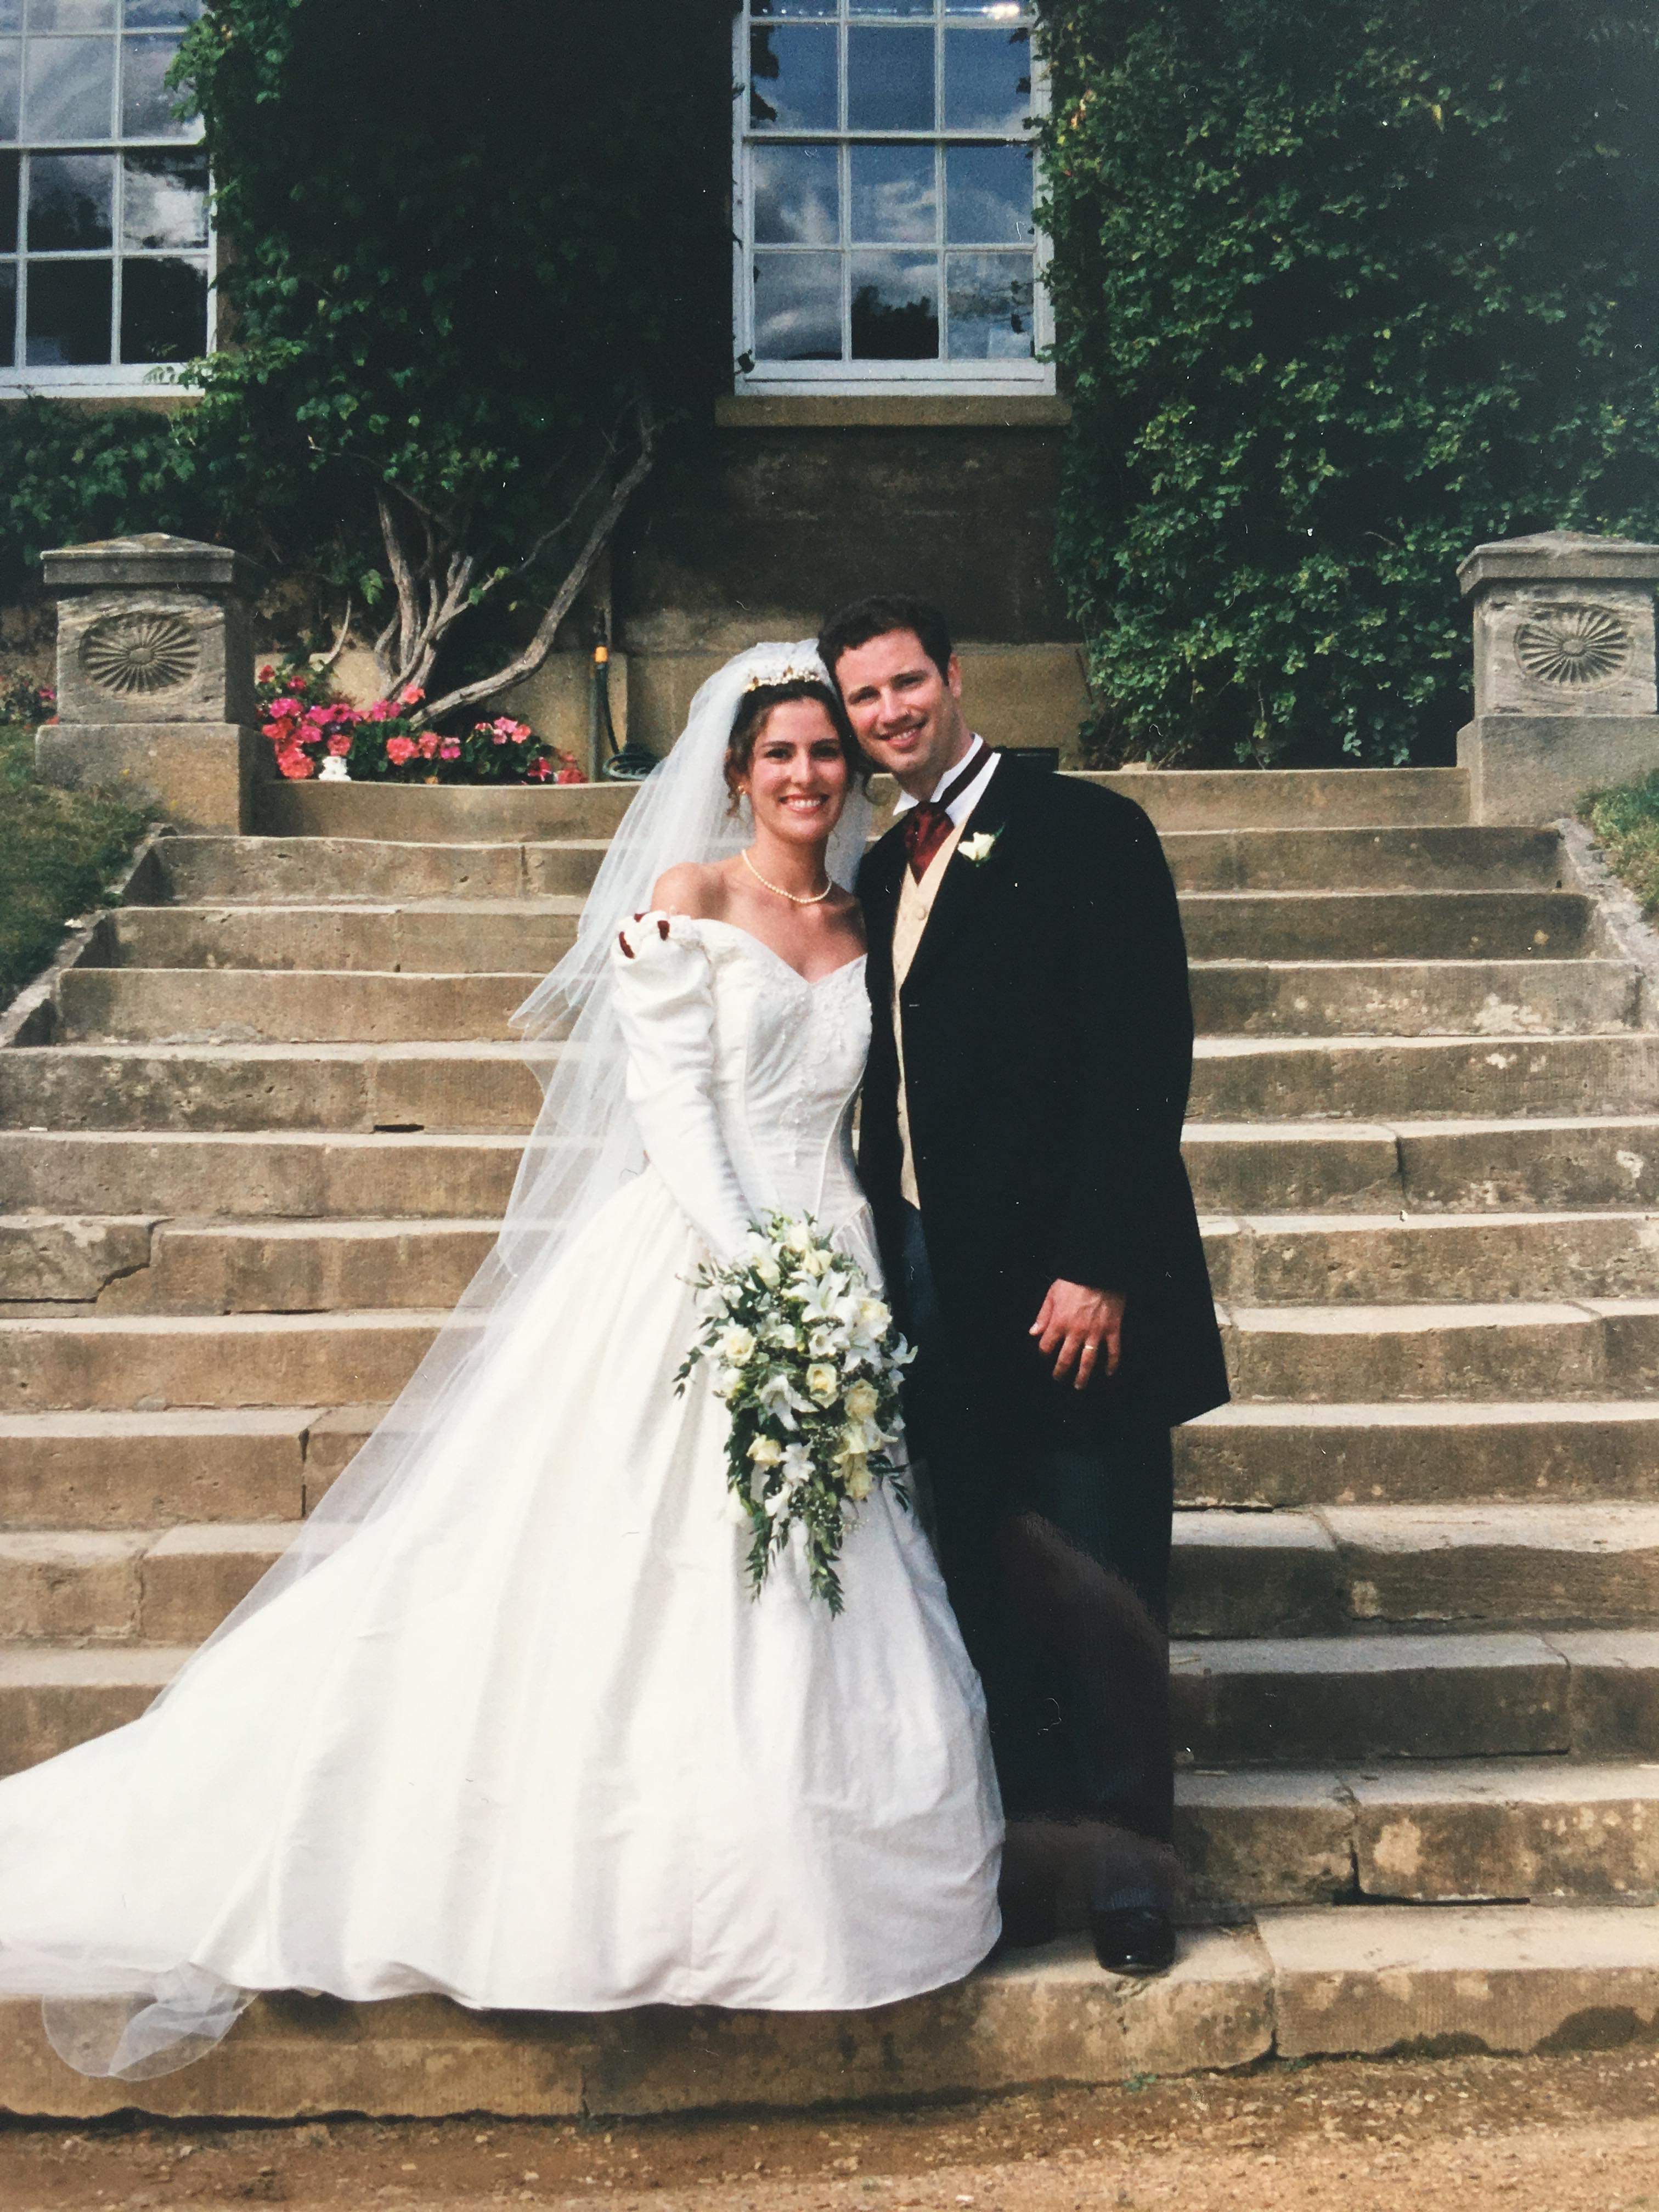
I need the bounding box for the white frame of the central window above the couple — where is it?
[732,0,1055,398]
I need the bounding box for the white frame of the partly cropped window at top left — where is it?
[0,20,219,400]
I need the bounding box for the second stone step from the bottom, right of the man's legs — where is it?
[1175,1758,1659,1907]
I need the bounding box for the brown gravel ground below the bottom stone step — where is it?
[0,2049,1659,2212]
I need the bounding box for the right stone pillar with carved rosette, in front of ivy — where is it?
[1458,531,1659,823]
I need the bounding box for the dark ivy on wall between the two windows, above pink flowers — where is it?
[0,0,732,681]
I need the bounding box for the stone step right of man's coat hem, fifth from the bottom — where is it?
[1175,1398,1659,1506]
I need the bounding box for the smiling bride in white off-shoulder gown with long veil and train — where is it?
[0,644,1000,2079]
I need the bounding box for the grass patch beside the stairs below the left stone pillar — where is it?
[0,721,146,1007]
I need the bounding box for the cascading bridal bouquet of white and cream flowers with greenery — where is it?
[675,1215,913,1612]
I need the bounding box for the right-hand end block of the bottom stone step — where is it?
[1256,1905,1659,2059]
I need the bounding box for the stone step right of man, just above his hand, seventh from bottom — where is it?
[1203,1212,1659,1305]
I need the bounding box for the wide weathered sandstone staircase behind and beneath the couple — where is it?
[0,770,1659,2113]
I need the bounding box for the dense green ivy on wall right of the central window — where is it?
[1044,0,1659,765]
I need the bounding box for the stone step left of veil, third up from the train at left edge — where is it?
[0,1407,358,1531]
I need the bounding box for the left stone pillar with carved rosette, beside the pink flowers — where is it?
[36,531,270,836]
